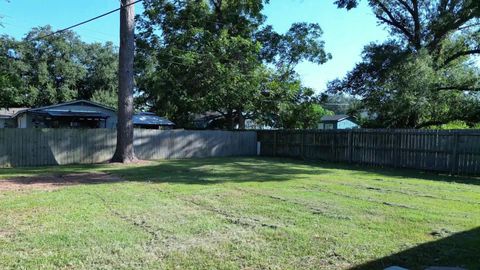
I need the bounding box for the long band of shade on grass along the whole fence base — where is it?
[0,157,480,185]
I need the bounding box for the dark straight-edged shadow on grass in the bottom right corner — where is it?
[350,227,480,270]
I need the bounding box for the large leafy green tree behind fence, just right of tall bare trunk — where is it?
[137,0,330,129]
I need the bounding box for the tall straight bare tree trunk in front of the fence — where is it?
[112,0,137,163]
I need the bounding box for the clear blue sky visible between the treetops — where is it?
[0,0,387,91]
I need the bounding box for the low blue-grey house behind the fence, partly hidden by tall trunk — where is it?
[0,100,173,129]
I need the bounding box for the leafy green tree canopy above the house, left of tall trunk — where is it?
[0,26,118,107]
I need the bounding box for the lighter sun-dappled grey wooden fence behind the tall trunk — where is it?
[0,129,257,167]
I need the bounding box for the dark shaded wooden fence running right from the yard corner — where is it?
[257,129,480,175]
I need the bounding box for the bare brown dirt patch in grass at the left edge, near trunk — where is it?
[0,173,122,191]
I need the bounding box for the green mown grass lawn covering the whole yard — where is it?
[0,158,480,269]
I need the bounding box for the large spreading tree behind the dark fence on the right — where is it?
[329,0,480,128]
